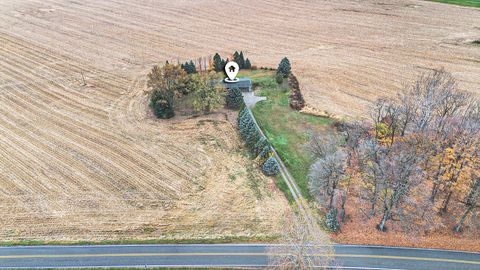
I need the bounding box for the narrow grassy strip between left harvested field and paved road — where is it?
[0,236,278,246]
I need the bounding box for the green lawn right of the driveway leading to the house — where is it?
[248,70,333,199]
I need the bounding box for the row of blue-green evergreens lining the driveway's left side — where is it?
[238,107,280,176]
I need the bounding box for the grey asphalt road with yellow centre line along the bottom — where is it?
[0,244,480,270]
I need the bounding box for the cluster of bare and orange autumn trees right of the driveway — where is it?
[308,69,480,232]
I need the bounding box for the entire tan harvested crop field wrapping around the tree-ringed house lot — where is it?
[0,0,480,240]
